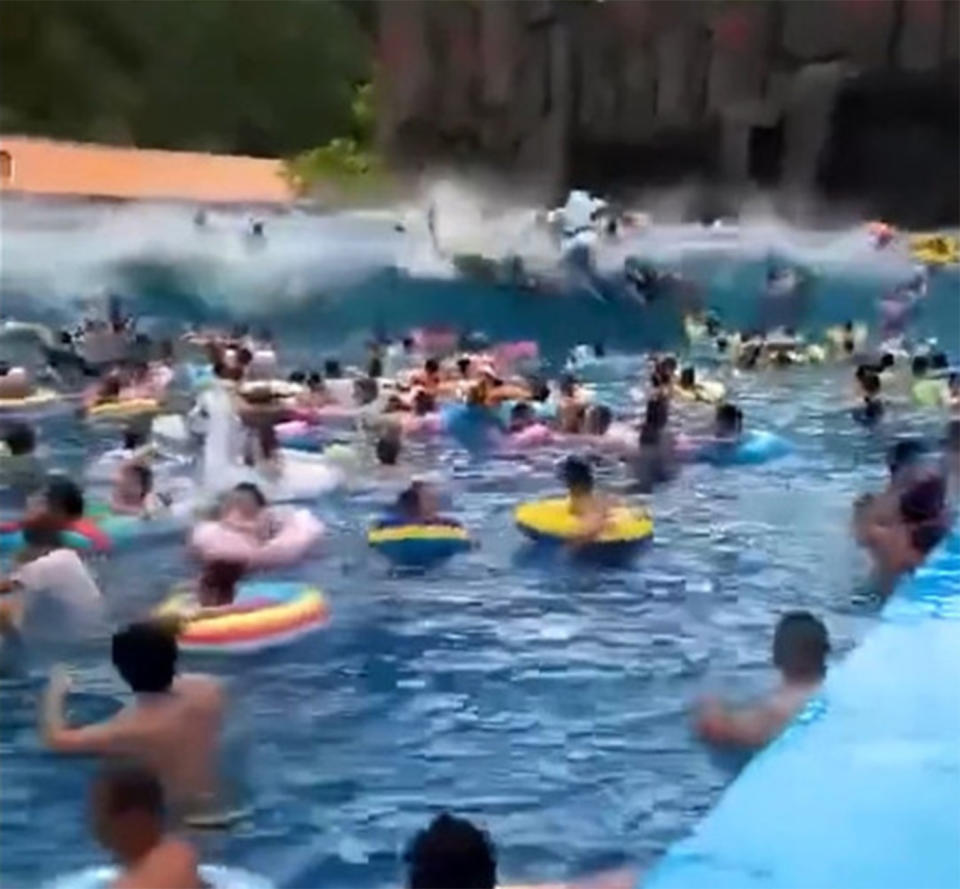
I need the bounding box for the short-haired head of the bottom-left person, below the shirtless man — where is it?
[90,762,166,862]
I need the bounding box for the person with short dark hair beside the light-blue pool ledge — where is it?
[696,611,830,748]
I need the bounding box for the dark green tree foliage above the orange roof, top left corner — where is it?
[0,0,372,156]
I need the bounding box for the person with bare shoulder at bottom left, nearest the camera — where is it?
[90,763,207,889]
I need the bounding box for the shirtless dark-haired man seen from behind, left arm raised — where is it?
[40,622,223,824]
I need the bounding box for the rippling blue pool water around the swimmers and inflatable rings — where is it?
[0,198,957,889]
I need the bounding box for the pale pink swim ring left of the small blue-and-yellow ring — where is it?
[190,509,324,569]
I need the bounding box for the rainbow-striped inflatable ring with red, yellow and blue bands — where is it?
[155,581,330,654]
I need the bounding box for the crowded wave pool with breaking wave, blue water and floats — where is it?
[0,198,960,889]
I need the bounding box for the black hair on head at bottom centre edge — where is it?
[404,812,497,889]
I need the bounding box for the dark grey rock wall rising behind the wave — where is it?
[378,0,960,224]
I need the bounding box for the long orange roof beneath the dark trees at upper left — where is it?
[0,136,294,203]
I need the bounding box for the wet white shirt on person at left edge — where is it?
[13,549,103,638]
